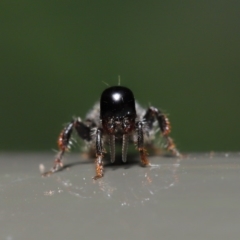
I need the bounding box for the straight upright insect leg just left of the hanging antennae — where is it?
[93,128,104,180]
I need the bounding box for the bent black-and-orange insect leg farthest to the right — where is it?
[144,107,181,157]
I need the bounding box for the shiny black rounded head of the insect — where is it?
[100,86,136,132]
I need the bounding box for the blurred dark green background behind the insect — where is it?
[0,0,240,151]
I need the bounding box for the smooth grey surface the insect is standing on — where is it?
[0,153,240,240]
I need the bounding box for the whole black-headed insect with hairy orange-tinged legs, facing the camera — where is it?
[43,86,180,180]
